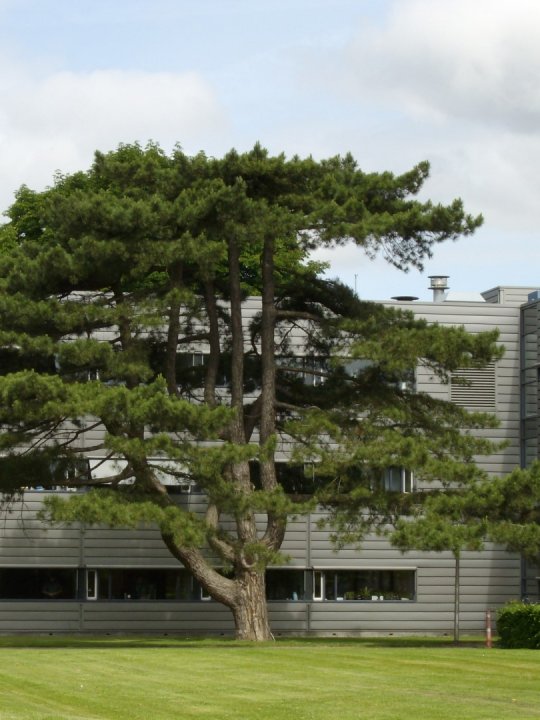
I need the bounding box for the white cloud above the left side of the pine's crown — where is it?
[0,67,226,207]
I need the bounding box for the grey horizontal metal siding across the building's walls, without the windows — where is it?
[0,288,528,634]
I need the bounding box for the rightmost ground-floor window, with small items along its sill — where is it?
[313,569,416,600]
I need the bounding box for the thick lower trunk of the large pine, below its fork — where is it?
[231,570,273,641]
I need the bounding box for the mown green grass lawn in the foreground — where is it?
[0,636,540,720]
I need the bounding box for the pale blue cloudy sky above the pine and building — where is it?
[0,0,540,300]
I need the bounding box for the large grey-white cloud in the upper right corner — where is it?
[345,0,540,133]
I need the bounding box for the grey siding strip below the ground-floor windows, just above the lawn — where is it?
[0,596,516,634]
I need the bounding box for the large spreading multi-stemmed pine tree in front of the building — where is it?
[0,145,498,640]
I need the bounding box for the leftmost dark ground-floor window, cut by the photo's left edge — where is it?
[0,568,77,600]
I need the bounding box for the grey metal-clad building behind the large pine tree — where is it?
[0,279,540,634]
